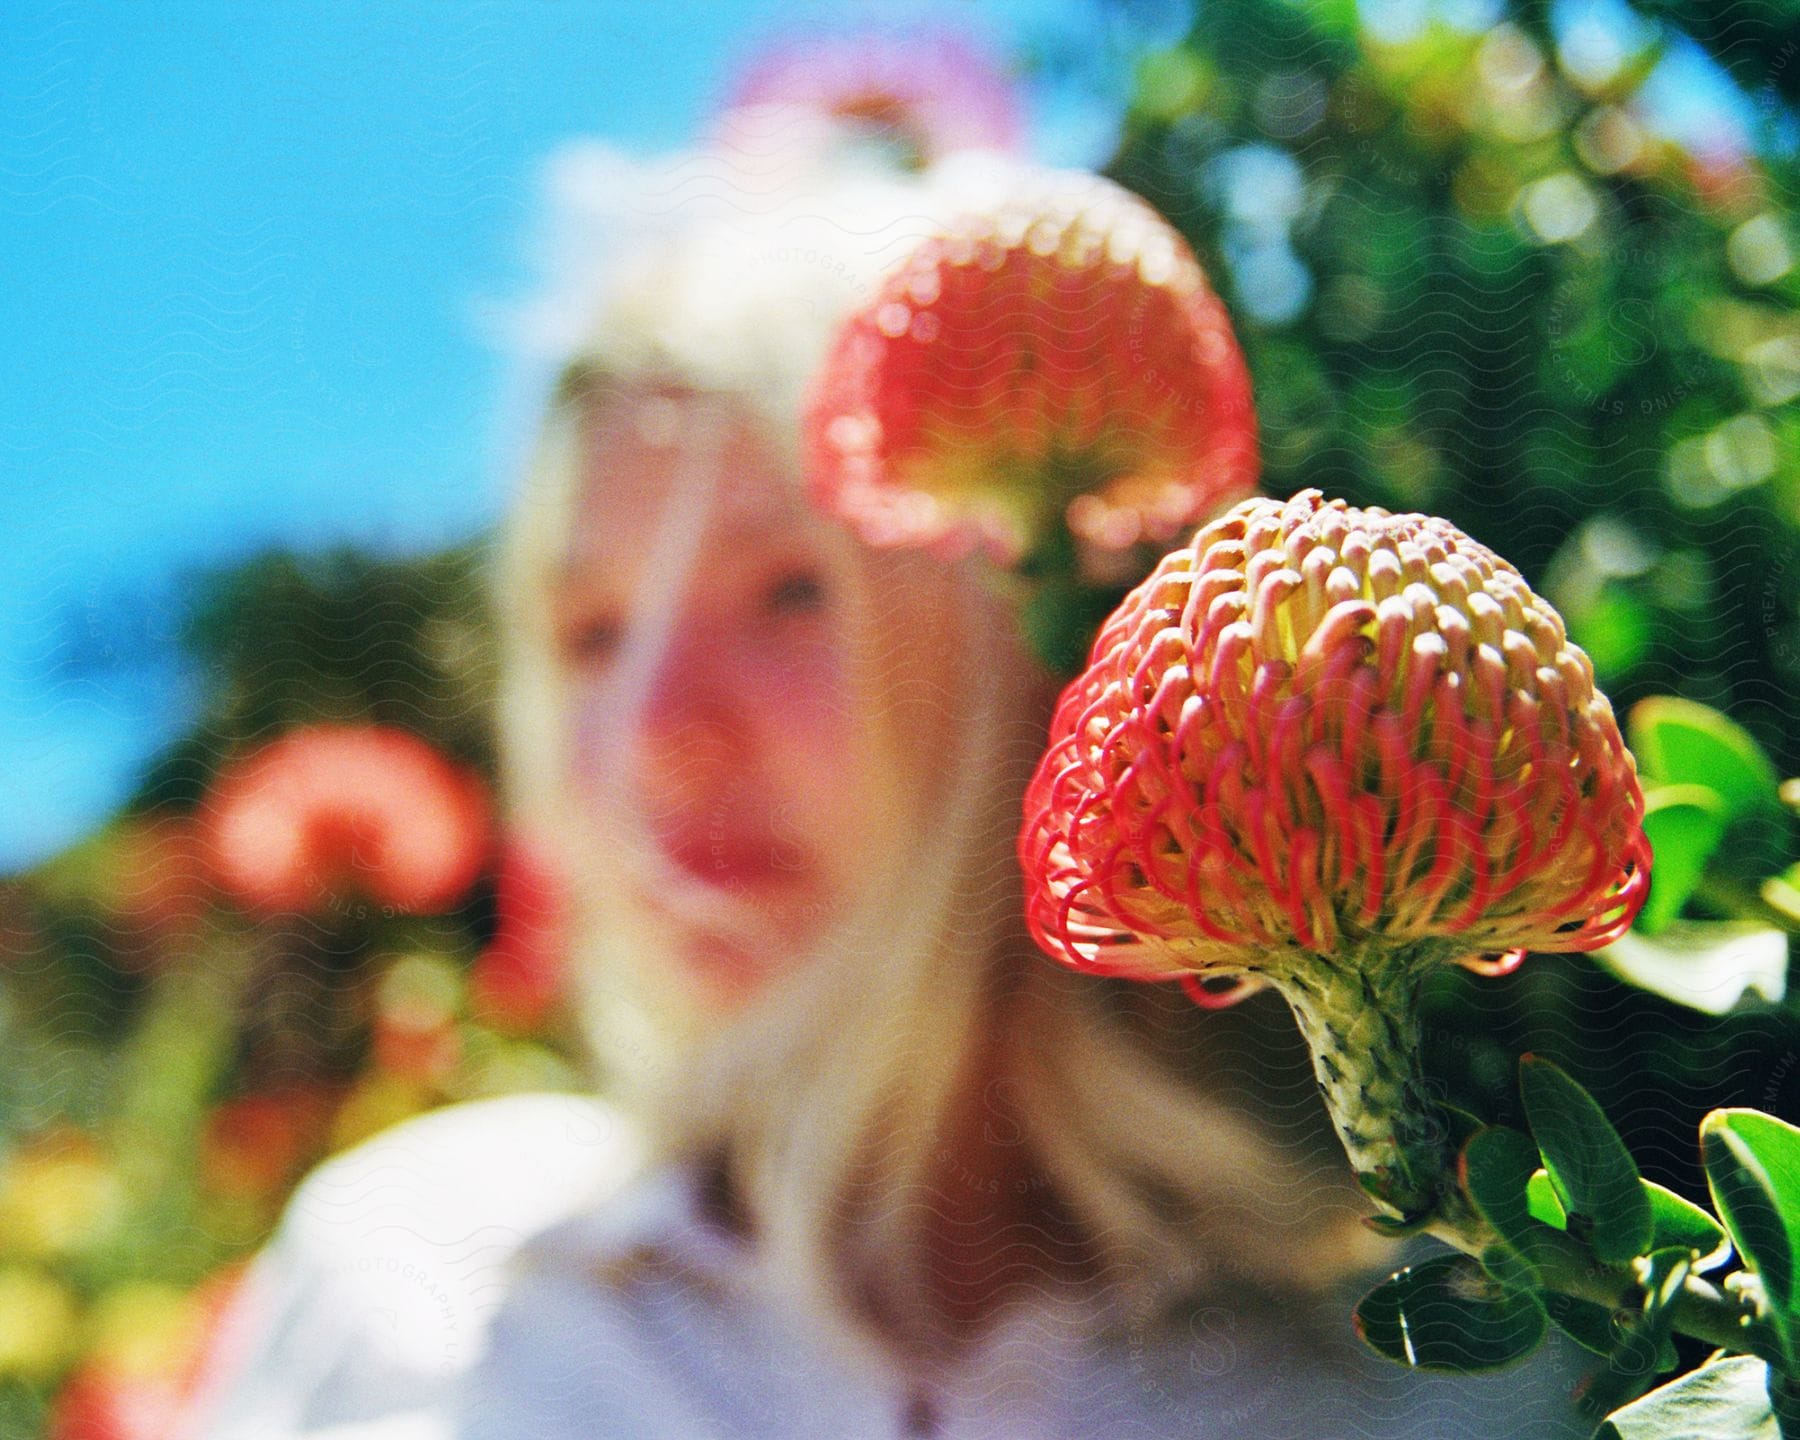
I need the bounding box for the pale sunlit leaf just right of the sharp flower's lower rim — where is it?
[1595,920,1787,1015]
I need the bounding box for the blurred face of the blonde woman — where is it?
[553,394,885,1003]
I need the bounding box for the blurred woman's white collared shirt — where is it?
[189,1094,1588,1440]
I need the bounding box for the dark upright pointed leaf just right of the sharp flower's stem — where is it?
[1519,1055,1651,1264]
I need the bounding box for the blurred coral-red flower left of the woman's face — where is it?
[203,725,490,914]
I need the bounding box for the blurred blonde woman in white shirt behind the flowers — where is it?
[186,120,1580,1440]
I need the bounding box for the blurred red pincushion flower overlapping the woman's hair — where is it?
[803,164,1256,563]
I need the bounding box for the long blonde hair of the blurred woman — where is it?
[499,132,1359,1375]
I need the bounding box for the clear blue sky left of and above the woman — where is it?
[0,0,1152,869]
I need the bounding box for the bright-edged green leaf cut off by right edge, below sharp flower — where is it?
[1699,1111,1800,1334]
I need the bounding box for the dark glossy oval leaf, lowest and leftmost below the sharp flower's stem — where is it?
[1355,1255,1546,1373]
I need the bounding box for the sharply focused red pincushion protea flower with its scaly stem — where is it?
[1019,491,1649,1213]
